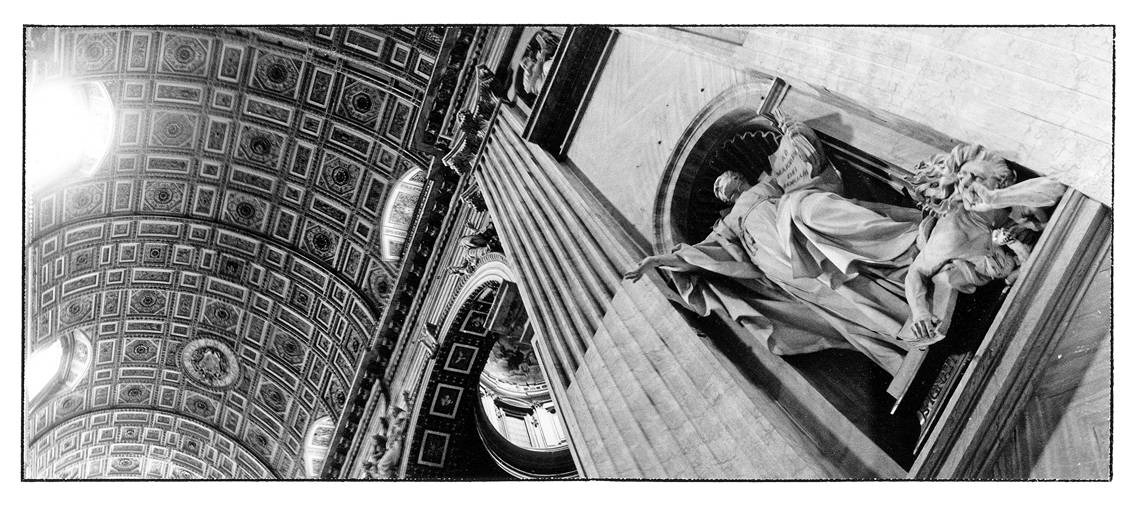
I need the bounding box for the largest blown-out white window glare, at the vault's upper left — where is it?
[25,81,114,189]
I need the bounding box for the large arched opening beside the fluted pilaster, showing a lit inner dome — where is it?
[406,260,577,479]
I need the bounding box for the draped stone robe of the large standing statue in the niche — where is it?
[666,166,921,374]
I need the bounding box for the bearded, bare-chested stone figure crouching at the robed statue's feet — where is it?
[903,145,1029,343]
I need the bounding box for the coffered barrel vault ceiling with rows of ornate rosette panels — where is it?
[25,27,440,478]
